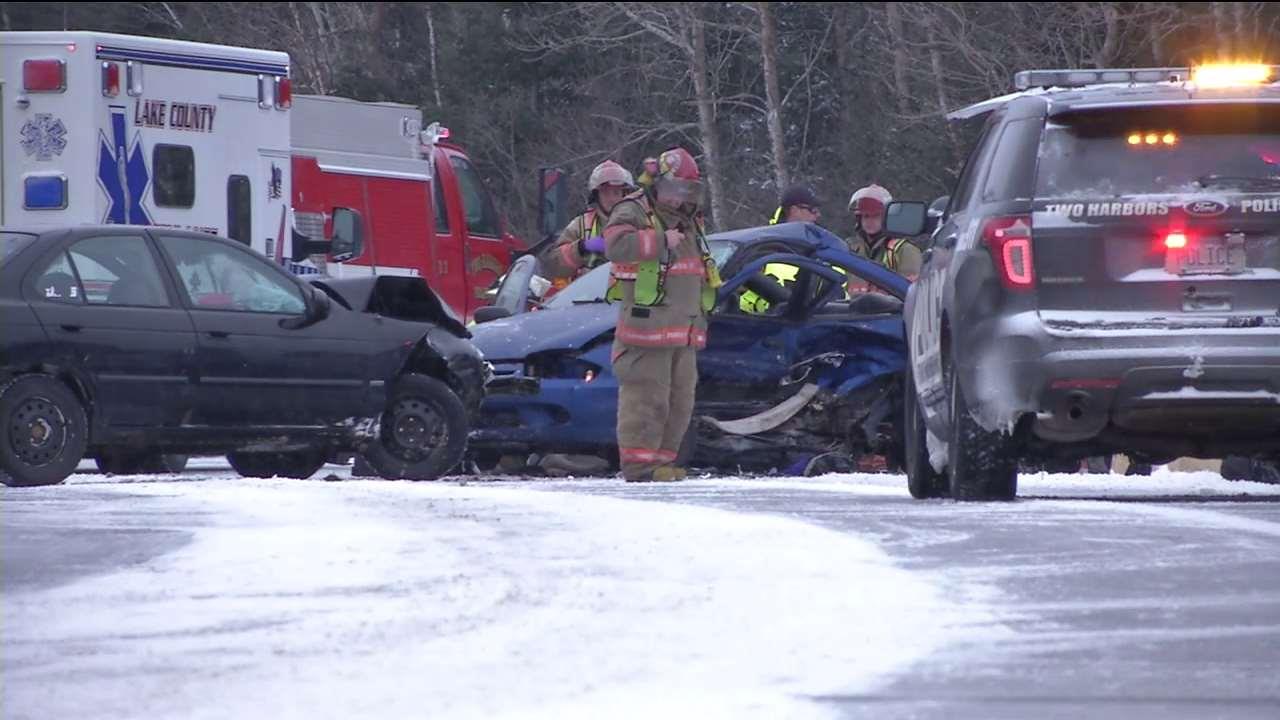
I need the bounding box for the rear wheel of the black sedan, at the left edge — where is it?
[0,375,88,487]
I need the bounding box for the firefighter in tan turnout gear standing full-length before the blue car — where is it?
[604,147,719,482]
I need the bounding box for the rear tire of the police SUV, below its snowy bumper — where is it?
[947,369,1018,500]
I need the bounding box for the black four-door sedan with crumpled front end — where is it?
[0,225,489,486]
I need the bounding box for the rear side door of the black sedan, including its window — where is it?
[26,228,196,428]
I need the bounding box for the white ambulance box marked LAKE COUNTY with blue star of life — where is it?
[0,32,292,260]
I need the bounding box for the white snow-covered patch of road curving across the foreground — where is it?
[0,466,1000,719]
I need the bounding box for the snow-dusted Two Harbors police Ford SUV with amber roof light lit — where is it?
[887,65,1280,500]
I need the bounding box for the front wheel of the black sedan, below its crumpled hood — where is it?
[364,374,467,480]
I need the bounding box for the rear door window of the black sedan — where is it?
[68,234,169,307]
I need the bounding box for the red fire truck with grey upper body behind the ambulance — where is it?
[291,95,524,319]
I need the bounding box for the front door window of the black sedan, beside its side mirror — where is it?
[160,236,306,315]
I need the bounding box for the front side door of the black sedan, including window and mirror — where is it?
[156,232,372,427]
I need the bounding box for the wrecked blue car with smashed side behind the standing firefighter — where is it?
[470,223,909,471]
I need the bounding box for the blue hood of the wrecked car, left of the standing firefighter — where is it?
[471,302,618,363]
